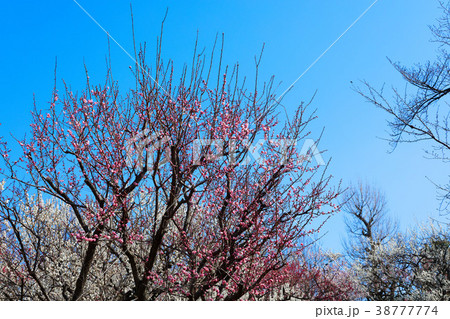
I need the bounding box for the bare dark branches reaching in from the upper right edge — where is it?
[356,2,450,212]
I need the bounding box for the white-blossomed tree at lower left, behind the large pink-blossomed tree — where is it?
[0,183,134,300]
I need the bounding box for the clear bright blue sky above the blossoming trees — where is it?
[0,0,448,254]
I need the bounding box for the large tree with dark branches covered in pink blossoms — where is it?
[0,41,339,300]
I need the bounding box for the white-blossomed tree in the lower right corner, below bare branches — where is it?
[353,223,450,301]
